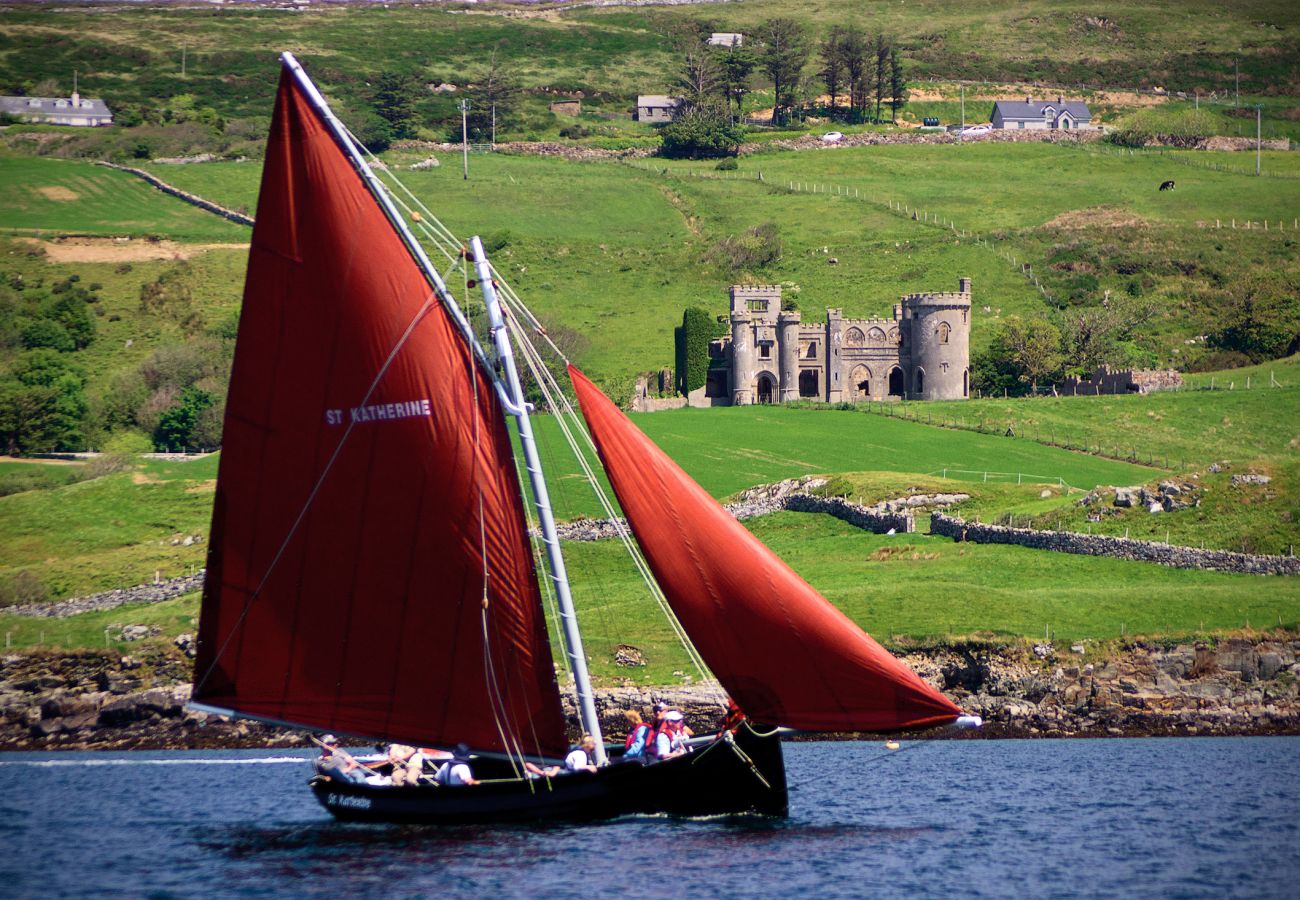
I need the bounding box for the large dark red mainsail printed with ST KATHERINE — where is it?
[194,72,566,753]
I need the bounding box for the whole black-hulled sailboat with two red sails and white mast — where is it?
[192,53,977,823]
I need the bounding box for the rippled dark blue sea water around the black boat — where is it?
[0,737,1300,897]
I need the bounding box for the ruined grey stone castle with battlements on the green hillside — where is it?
[707,278,971,406]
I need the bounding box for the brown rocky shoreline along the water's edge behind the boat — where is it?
[0,633,1300,750]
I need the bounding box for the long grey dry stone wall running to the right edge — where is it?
[930,512,1300,575]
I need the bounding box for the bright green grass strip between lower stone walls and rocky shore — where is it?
[0,512,1300,684]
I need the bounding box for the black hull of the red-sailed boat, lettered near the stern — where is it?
[311,726,789,825]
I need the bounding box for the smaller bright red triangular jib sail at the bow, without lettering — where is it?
[569,367,961,731]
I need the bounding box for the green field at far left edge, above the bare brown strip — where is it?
[0,153,250,242]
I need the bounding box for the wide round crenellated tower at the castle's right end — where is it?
[902,278,971,401]
